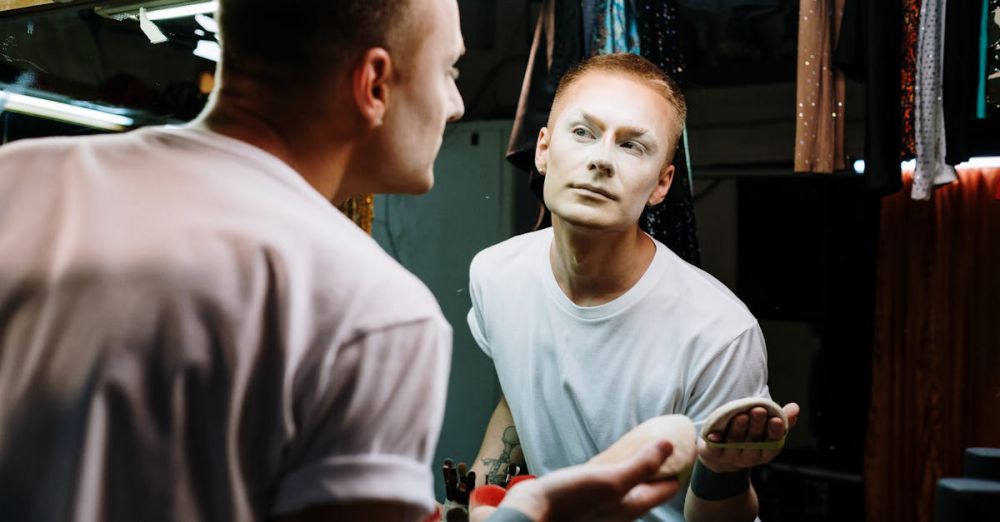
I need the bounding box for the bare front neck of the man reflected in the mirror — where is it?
[549,216,656,306]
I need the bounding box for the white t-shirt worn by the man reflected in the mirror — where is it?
[468,228,769,520]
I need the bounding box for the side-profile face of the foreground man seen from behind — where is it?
[373,0,465,194]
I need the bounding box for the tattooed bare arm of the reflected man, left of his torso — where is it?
[472,396,524,486]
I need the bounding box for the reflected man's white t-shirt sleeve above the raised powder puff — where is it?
[685,321,771,433]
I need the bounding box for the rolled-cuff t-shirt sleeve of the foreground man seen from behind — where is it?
[271,318,451,519]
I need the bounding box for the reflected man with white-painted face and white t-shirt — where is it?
[468,54,798,521]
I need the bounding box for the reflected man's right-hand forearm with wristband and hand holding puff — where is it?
[684,403,799,522]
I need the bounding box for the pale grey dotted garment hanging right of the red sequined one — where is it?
[910,0,962,199]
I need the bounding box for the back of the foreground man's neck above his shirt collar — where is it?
[192,79,350,203]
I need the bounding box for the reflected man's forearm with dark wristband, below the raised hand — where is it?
[684,462,758,522]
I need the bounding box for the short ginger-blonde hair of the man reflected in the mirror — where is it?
[547,53,687,160]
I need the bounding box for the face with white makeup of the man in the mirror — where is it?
[535,71,677,230]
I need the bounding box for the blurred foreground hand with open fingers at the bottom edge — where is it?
[475,441,680,522]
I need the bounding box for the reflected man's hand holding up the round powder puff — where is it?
[698,402,799,473]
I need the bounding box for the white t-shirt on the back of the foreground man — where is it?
[0,128,451,521]
